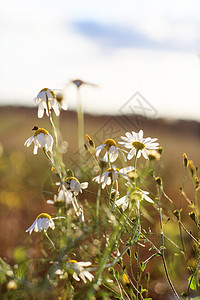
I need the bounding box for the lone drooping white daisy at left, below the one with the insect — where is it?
[26,213,55,234]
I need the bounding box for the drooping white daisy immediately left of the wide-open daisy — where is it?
[96,139,126,163]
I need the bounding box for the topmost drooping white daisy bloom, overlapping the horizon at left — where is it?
[33,88,67,118]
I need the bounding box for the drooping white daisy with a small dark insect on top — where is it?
[24,126,53,155]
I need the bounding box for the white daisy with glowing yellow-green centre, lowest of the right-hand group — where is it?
[115,182,154,211]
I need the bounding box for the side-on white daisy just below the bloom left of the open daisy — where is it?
[93,165,134,189]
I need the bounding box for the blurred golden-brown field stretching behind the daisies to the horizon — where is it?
[0,107,200,299]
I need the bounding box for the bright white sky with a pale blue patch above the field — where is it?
[0,0,200,120]
